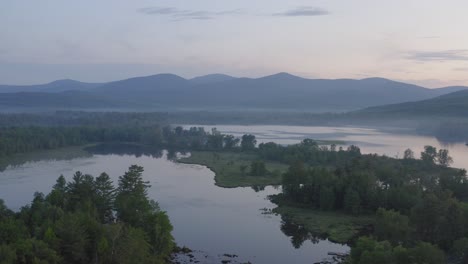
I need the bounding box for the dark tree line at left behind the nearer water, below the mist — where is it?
[0,125,262,158]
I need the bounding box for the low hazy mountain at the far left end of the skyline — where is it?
[0,79,101,93]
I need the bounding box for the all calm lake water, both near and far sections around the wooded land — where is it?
[0,126,468,263]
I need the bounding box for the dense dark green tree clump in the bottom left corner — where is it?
[0,165,174,264]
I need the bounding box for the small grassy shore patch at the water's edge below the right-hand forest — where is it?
[273,206,374,244]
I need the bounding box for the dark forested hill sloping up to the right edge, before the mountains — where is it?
[355,90,468,117]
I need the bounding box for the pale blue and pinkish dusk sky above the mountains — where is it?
[0,0,468,88]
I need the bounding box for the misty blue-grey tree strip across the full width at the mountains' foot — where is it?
[0,111,468,142]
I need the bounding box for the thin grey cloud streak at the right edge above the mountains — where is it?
[406,50,468,62]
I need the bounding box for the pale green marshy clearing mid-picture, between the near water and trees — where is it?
[178,151,288,188]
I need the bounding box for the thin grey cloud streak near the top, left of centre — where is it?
[137,7,243,21]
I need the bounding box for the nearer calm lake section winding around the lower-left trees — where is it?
[0,152,348,263]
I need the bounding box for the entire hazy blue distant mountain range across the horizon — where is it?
[0,73,468,112]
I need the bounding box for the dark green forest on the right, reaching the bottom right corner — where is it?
[258,140,468,263]
